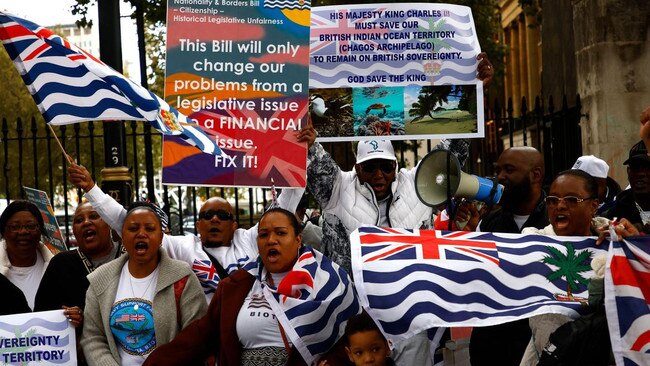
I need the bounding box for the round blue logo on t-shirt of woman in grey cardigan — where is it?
[109,298,156,356]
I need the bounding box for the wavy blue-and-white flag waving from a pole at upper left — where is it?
[0,12,222,155]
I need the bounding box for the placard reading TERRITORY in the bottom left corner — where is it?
[0,310,77,365]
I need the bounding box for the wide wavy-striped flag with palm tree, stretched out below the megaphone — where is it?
[350,227,605,343]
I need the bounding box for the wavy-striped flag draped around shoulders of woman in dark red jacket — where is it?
[249,246,361,365]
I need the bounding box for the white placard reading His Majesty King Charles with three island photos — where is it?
[309,3,484,141]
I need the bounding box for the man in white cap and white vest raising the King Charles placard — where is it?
[298,120,469,273]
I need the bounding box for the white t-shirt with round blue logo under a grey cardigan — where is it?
[108,261,158,366]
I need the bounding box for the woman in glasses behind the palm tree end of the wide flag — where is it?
[522,169,638,365]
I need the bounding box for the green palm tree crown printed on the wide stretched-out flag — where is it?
[542,243,591,296]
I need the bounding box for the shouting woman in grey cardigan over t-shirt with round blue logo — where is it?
[81,202,206,365]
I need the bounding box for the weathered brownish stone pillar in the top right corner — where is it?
[572,0,650,187]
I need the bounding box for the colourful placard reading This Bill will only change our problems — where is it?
[163,0,309,187]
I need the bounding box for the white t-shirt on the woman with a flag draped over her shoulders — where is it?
[237,273,289,349]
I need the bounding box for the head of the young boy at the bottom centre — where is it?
[345,311,390,366]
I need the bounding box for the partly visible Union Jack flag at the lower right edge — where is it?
[605,236,650,365]
